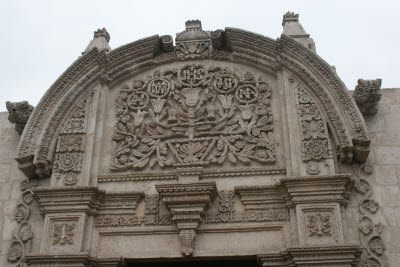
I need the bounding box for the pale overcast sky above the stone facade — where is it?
[0,0,400,111]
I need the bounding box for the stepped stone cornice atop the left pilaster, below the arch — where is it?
[33,186,144,217]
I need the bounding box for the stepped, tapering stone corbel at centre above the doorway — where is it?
[156,183,217,256]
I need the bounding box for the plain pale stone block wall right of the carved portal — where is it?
[365,88,400,266]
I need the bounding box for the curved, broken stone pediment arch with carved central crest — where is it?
[17,21,369,177]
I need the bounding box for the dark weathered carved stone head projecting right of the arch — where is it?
[353,79,382,115]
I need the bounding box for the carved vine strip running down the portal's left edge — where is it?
[7,180,37,267]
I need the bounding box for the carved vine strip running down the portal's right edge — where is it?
[353,164,388,267]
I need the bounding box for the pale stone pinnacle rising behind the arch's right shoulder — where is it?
[282,11,316,53]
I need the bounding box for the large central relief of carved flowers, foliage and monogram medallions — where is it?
[110,65,275,171]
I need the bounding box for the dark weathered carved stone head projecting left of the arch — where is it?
[6,101,33,135]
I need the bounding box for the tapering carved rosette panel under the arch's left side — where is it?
[53,100,87,186]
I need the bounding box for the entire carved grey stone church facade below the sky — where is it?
[0,12,400,267]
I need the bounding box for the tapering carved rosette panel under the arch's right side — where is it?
[297,86,330,175]
